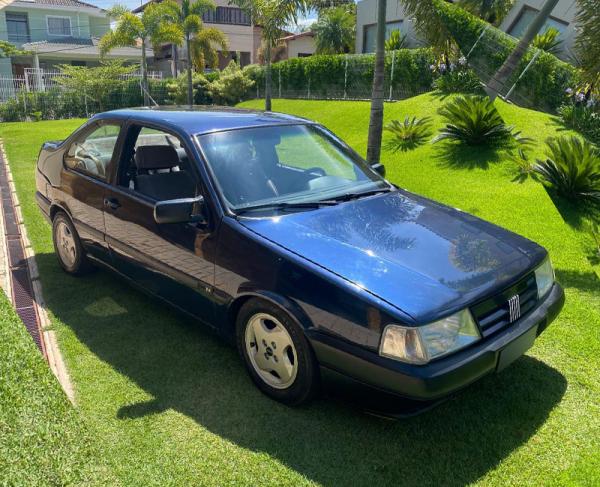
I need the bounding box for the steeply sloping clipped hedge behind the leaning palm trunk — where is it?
[431,0,581,112]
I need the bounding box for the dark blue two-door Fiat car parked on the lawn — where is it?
[36,109,564,405]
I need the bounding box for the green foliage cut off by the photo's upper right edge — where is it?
[576,0,600,85]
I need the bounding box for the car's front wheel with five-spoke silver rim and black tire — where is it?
[236,299,319,406]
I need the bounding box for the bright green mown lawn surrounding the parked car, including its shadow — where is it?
[0,95,600,485]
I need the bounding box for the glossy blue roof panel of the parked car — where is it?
[92,106,314,135]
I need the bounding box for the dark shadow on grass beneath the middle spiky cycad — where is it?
[434,142,507,170]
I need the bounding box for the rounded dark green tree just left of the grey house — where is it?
[312,7,356,54]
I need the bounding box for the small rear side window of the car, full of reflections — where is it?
[65,124,121,180]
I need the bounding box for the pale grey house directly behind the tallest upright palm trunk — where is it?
[356,0,422,53]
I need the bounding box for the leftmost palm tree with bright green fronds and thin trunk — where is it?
[100,3,181,105]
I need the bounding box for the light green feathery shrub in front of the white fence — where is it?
[57,61,137,111]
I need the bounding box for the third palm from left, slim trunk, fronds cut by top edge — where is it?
[231,0,313,111]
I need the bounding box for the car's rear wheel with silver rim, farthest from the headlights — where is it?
[52,211,93,276]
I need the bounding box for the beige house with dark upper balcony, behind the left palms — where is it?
[133,0,262,75]
